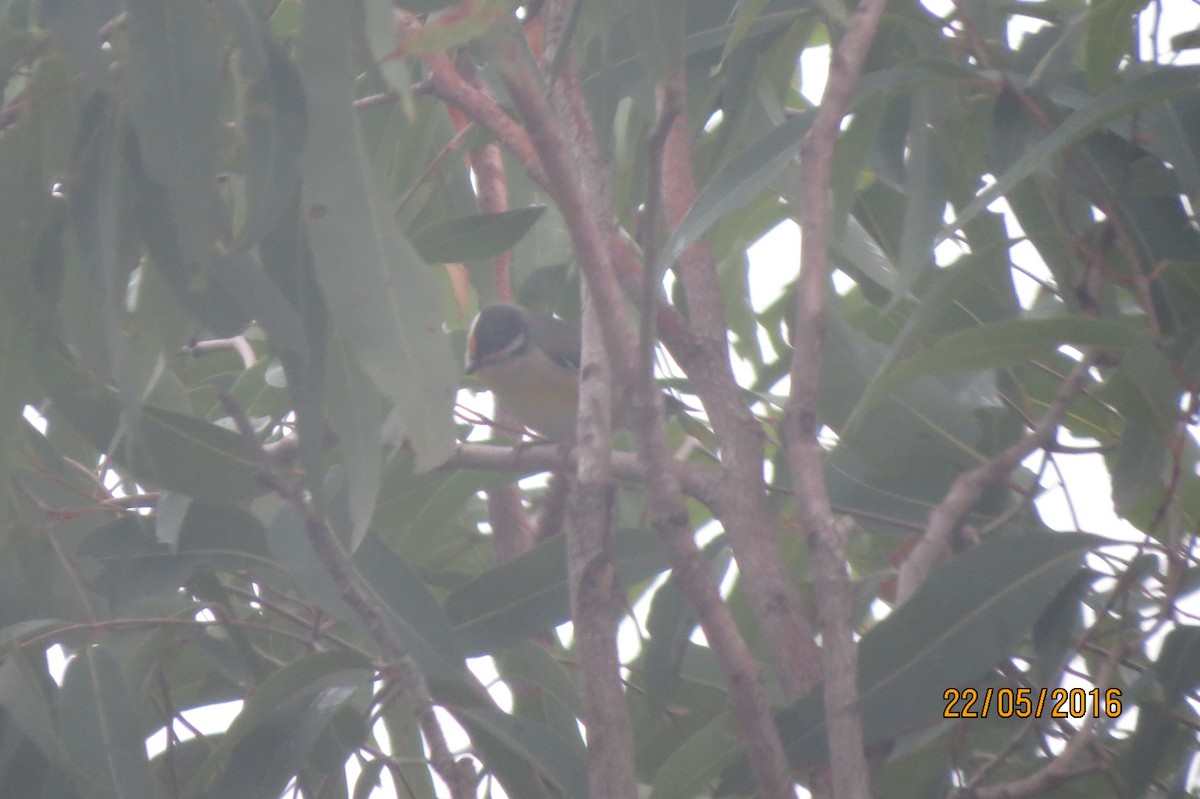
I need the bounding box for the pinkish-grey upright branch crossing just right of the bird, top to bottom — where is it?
[477,17,637,799]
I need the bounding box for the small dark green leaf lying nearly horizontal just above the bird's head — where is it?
[409,205,546,264]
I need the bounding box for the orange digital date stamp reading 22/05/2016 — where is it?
[942,687,1121,719]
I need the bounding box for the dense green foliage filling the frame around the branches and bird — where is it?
[0,0,1200,799]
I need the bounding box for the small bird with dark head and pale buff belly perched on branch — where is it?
[466,302,581,444]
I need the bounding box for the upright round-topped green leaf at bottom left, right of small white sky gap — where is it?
[59,647,160,799]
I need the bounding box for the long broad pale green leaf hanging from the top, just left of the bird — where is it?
[299,0,457,470]
